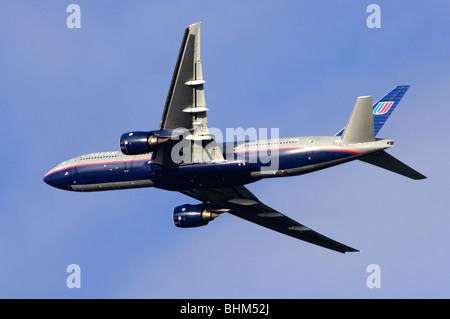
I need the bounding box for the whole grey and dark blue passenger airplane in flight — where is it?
[43,22,426,253]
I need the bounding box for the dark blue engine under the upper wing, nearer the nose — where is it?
[120,131,170,155]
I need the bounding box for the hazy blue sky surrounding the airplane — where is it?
[0,0,450,298]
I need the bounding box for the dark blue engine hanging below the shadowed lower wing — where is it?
[172,205,219,228]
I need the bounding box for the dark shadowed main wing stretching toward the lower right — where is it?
[182,186,358,253]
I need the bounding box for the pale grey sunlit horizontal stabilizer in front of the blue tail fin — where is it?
[341,96,375,144]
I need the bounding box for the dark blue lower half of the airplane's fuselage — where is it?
[44,150,355,191]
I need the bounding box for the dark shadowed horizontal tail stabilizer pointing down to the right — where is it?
[360,151,426,180]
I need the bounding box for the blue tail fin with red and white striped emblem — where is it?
[335,85,409,136]
